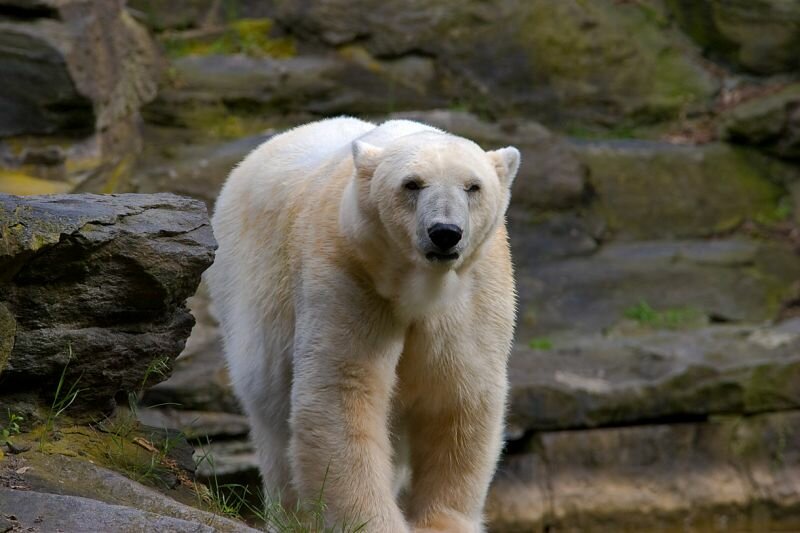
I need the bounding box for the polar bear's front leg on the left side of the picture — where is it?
[290,281,409,533]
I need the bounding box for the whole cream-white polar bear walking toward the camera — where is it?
[208,118,520,533]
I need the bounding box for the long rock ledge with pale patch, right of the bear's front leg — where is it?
[509,318,800,431]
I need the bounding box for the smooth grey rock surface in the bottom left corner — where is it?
[0,488,222,533]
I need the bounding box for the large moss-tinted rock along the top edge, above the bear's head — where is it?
[275,0,716,124]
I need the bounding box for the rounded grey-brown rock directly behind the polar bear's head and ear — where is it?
[392,110,586,209]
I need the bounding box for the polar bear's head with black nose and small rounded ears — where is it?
[344,130,520,269]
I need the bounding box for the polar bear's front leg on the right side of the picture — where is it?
[399,319,511,533]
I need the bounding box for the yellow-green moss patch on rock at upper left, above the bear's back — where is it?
[163,18,297,58]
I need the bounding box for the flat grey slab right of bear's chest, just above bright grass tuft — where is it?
[511,237,800,336]
